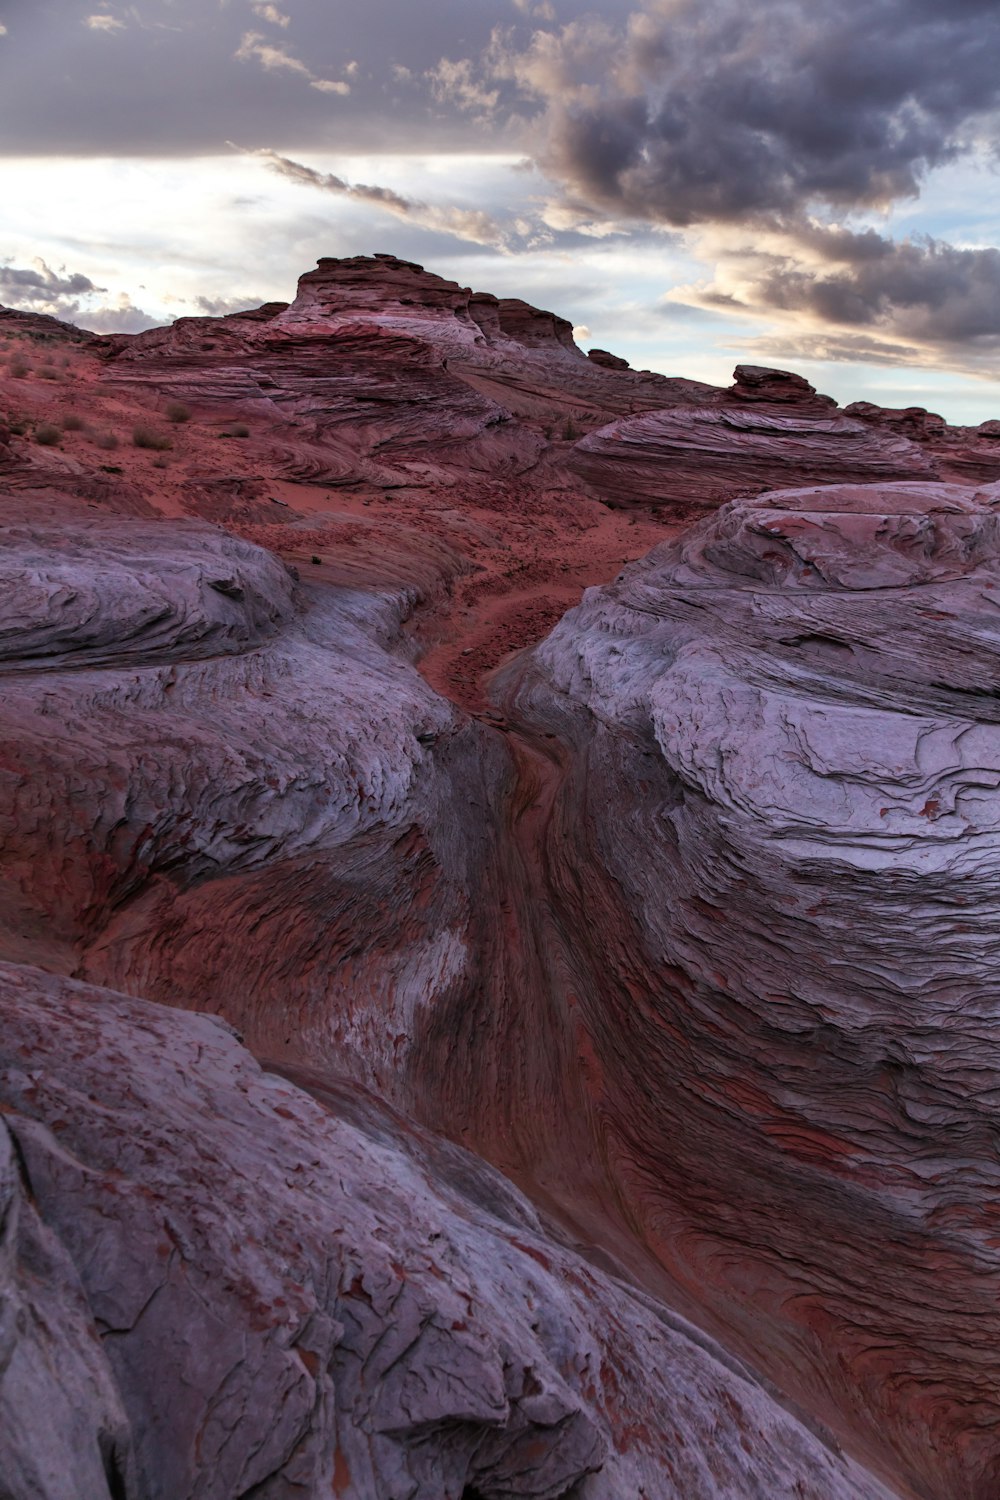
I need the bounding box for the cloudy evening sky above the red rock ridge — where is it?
[0,0,1000,423]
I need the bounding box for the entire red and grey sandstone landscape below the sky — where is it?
[0,255,1000,1500]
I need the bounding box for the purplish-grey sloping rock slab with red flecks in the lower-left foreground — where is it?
[0,965,886,1500]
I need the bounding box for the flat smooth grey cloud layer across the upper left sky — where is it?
[0,0,515,158]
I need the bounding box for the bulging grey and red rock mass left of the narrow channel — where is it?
[0,504,502,1092]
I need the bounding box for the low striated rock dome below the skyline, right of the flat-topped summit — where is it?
[570,402,937,521]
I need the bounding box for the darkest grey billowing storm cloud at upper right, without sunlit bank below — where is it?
[486,0,1000,228]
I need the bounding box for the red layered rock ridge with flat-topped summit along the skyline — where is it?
[89,255,1000,518]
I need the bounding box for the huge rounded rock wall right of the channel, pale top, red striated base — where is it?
[507,485,1000,1500]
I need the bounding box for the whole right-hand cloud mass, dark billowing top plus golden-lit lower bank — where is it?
[470,0,1000,369]
